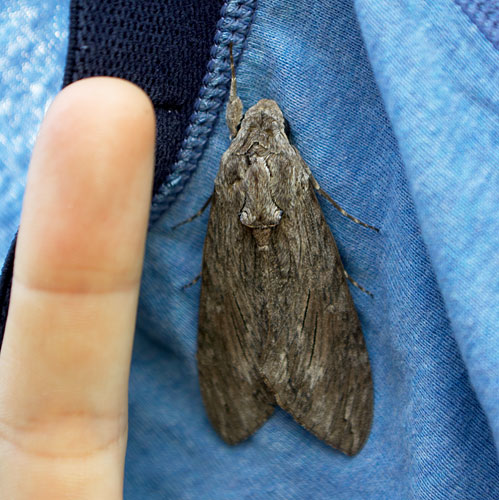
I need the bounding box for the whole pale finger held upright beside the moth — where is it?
[0,77,155,500]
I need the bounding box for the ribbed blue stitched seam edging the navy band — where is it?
[149,0,256,226]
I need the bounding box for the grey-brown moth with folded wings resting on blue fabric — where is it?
[193,47,376,455]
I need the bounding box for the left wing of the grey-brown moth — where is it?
[197,174,275,444]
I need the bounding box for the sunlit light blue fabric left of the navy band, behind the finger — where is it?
[0,0,69,262]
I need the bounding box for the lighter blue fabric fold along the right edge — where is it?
[358,1,499,460]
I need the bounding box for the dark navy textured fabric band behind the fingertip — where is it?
[64,0,223,192]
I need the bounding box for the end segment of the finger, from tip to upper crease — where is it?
[14,77,155,289]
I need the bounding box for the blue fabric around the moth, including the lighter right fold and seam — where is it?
[0,0,499,500]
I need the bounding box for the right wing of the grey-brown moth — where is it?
[260,146,373,455]
